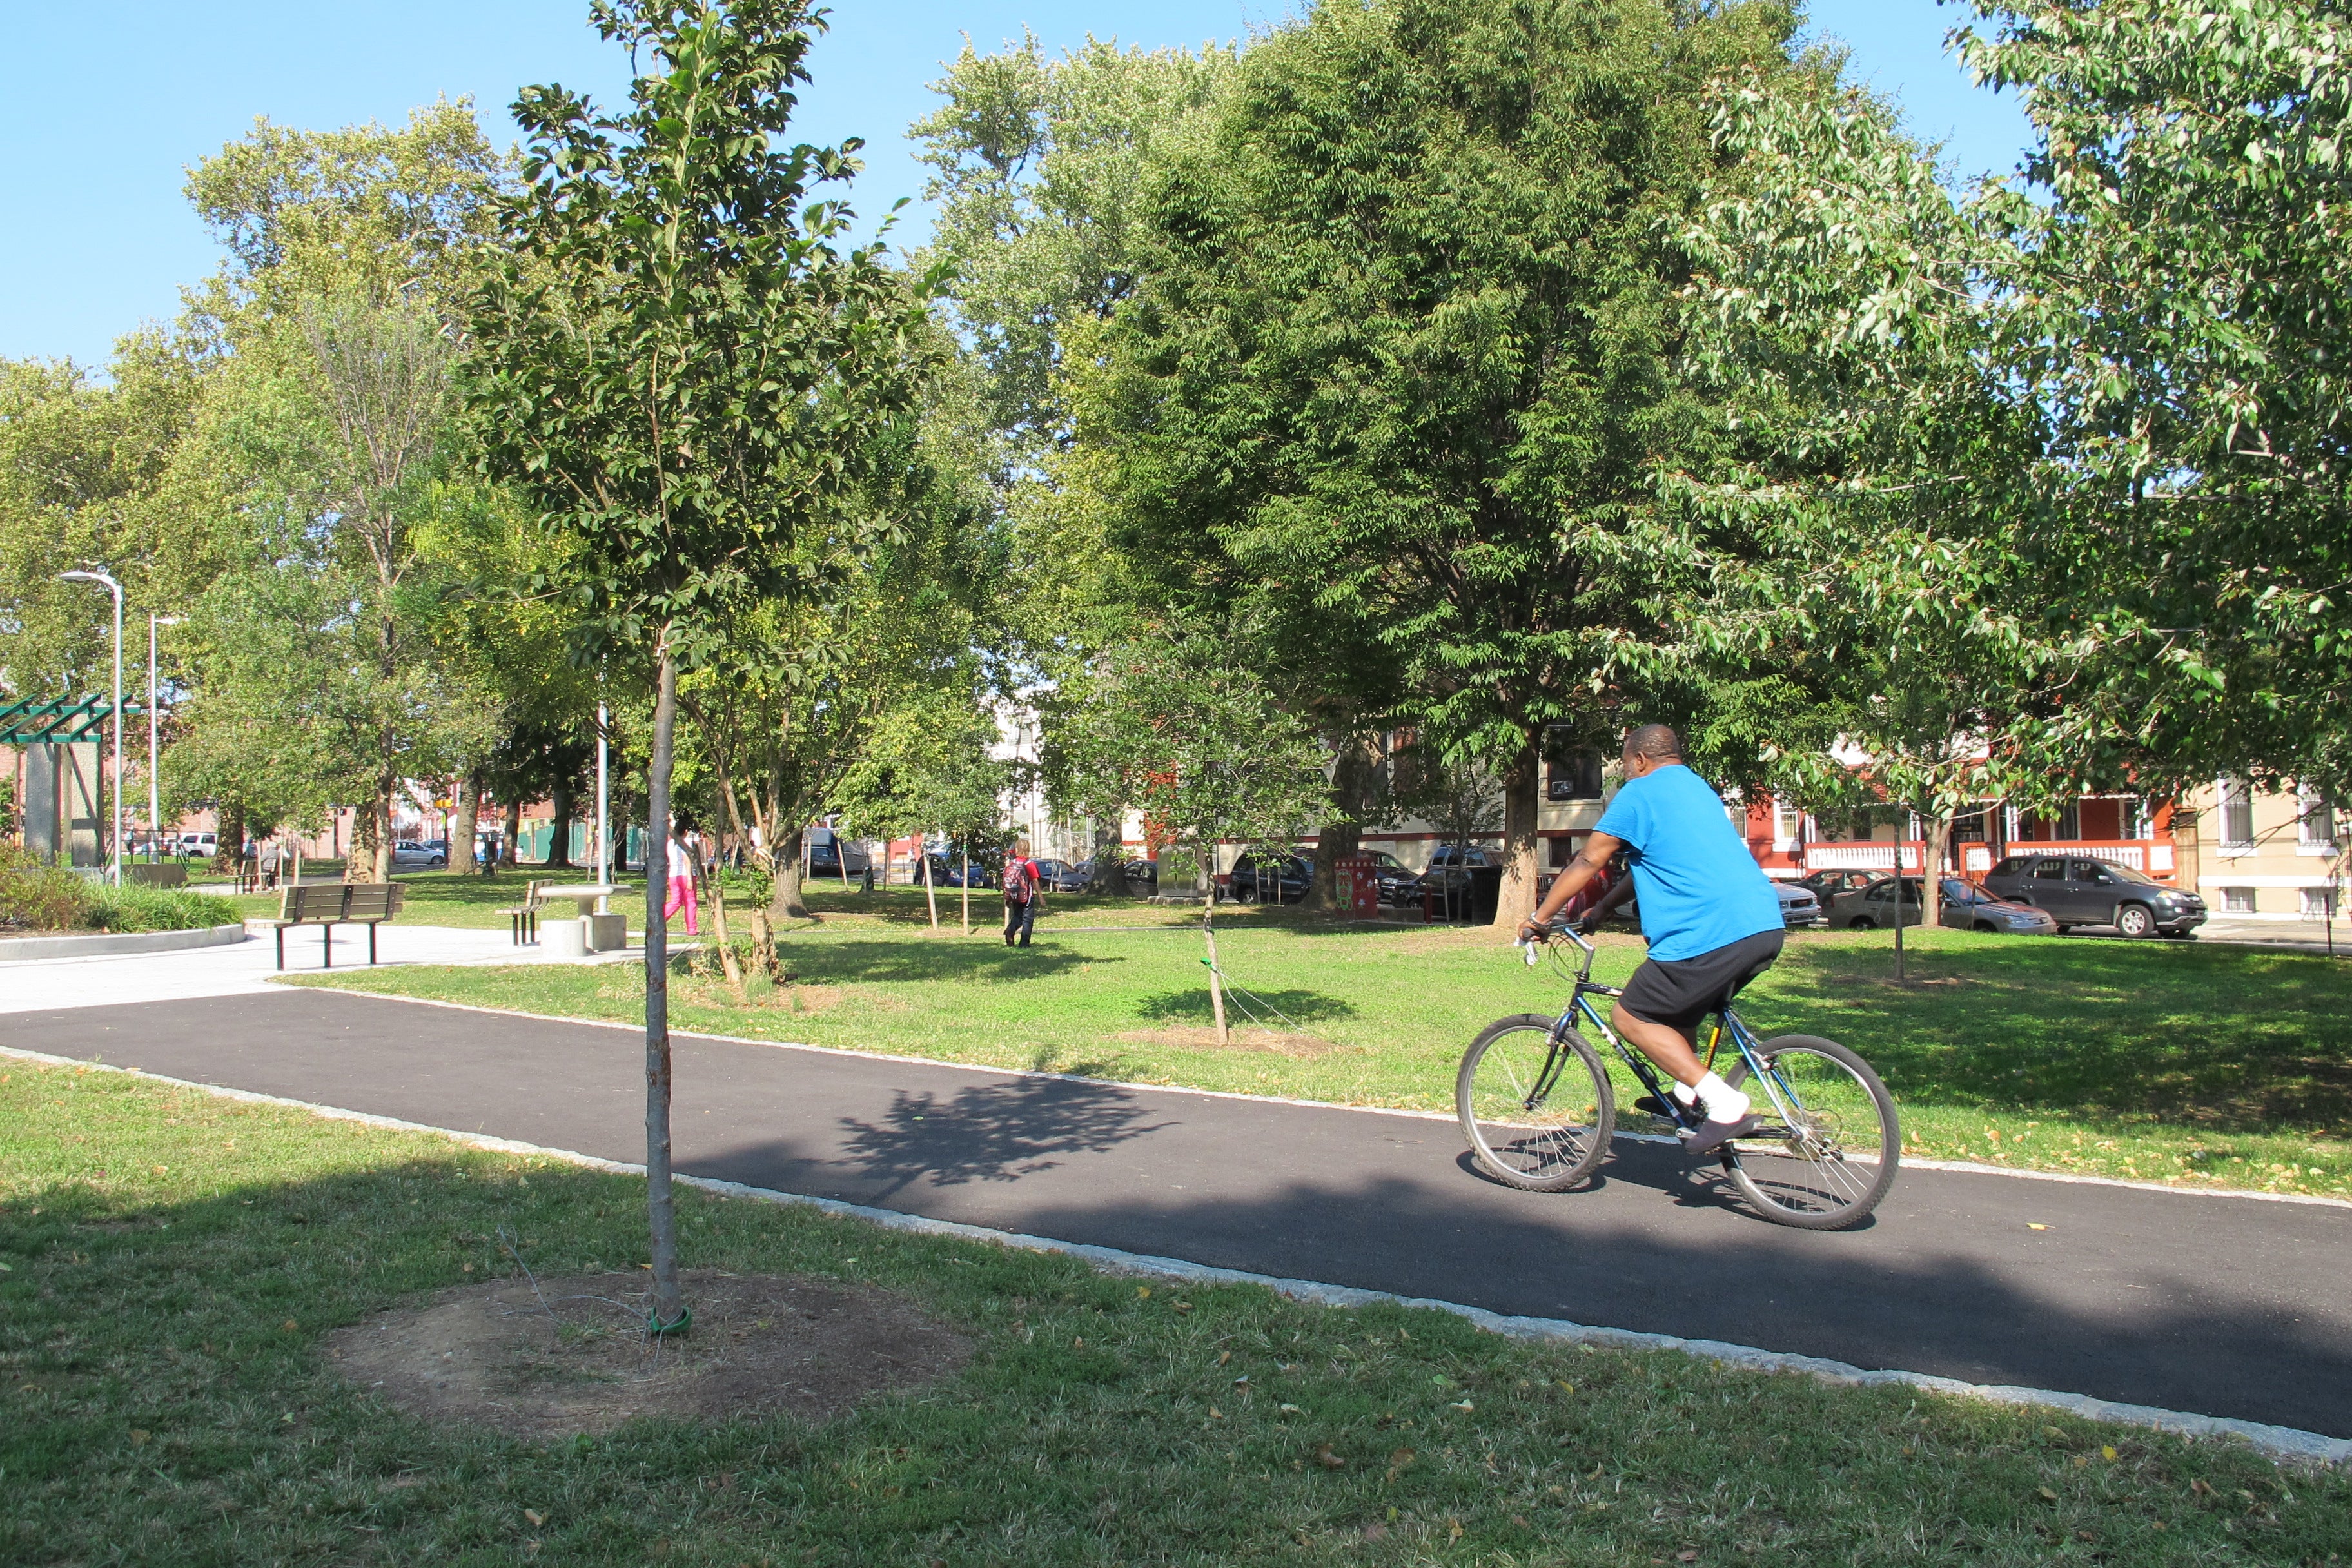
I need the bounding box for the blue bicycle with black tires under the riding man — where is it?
[1453,928,1903,1230]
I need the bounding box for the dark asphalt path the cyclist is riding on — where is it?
[0,987,2352,1436]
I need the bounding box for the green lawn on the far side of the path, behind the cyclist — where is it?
[289,900,2352,1197]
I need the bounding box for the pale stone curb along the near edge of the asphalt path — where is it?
[0,1046,2352,1467]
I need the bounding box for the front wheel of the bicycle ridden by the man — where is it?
[1453,1014,1616,1192]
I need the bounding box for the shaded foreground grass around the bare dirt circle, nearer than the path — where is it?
[0,1063,2352,1568]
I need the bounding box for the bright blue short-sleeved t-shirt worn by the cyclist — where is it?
[1597,761,1787,961]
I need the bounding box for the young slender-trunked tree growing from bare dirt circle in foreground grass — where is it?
[473,0,919,1331]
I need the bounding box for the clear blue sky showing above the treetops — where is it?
[0,0,2025,364]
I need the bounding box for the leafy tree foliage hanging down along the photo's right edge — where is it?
[1961,0,2352,803]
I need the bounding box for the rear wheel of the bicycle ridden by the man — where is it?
[1724,1034,1903,1230]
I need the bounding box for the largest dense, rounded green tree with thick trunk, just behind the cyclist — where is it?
[1079,0,1794,924]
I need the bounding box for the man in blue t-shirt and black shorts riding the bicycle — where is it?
[1520,724,1785,1154]
